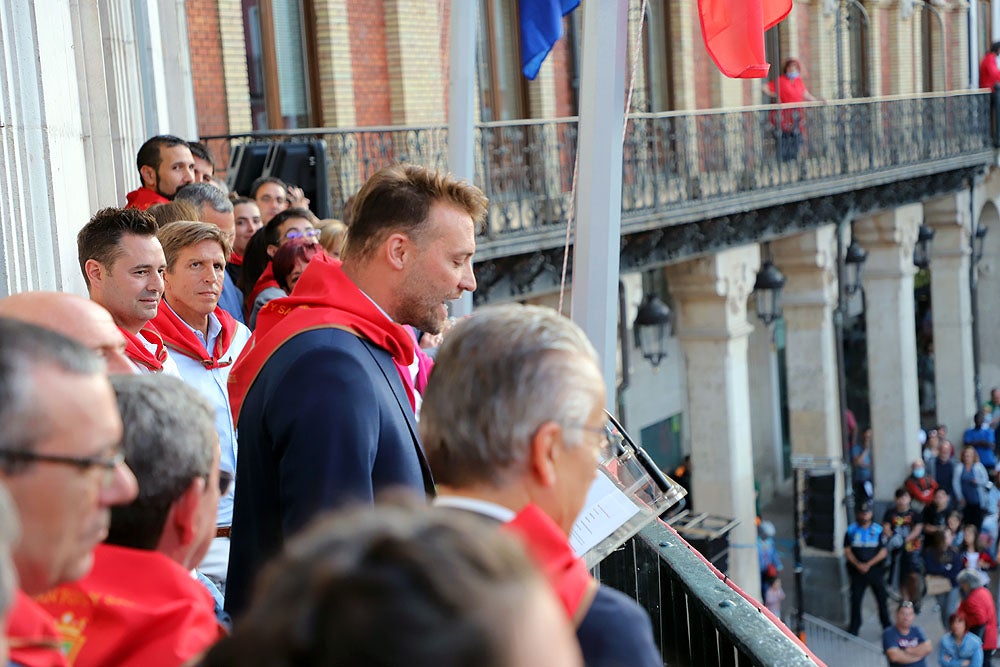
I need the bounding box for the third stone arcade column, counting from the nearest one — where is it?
[854,204,923,500]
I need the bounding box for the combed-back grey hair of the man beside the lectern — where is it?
[420,305,600,488]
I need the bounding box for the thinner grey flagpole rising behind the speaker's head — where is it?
[448,0,478,317]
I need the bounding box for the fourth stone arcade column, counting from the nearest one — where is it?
[924,190,976,433]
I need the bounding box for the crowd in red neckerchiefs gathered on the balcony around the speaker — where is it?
[0,136,663,667]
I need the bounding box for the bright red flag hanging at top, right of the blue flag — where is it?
[698,0,792,79]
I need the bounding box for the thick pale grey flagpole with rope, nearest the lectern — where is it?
[572,0,628,412]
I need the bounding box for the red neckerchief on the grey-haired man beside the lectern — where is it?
[504,504,593,618]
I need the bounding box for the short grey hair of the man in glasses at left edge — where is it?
[0,318,107,464]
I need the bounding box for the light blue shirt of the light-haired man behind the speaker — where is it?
[161,301,250,526]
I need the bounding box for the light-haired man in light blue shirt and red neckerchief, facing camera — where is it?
[153,222,250,590]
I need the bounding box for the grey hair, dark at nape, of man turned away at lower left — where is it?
[107,374,219,550]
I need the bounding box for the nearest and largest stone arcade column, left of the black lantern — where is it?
[667,245,760,597]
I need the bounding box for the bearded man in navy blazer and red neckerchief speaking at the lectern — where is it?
[226,165,487,614]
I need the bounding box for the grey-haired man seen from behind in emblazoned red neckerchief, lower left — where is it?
[36,375,226,667]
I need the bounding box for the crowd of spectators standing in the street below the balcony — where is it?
[844,404,1000,665]
